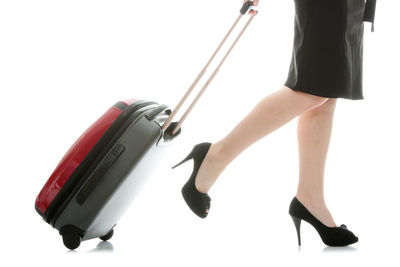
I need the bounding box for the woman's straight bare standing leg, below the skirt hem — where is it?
[296,98,337,227]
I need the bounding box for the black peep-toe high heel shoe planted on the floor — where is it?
[289,197,358,246]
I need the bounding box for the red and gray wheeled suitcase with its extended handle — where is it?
[35,1,260,249]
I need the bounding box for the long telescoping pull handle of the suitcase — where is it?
[162,1,258,137]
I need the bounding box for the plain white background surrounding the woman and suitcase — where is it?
[0,0,400,266]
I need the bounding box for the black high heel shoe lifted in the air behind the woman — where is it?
[172,142,212,219]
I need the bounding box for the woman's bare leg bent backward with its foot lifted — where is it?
[195,86,328,197]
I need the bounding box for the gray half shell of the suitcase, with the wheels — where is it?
[51,104,174,249]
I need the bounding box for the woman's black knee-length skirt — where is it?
[285,0,365,100]
